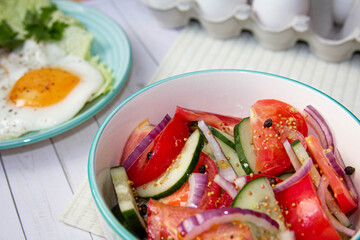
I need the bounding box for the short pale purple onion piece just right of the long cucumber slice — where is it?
[186,173,207,208]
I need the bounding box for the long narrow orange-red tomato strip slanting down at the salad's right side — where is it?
[305,135,358,213]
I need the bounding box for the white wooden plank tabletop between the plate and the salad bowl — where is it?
[0,0,181,239]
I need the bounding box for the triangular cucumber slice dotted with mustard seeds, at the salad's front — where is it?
[232,177,286,231]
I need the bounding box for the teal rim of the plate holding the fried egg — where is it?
[0,1,132,150]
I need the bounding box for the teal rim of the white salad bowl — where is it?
[88,69,360,240]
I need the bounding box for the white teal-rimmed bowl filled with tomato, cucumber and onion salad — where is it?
[89,70,360,239]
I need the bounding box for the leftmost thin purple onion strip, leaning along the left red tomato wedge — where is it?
[123,114,171,170]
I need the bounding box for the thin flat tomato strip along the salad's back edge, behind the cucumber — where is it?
[175,106,241,136]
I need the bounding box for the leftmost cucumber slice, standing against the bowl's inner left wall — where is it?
[110,166,146,237]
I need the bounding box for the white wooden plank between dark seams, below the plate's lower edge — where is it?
[2,140,91,239]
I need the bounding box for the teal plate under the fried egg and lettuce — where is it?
[0,1,131,149]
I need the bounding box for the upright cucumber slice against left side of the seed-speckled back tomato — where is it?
[234,117,256,175]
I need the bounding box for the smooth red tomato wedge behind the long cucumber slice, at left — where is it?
[127,117,189,187]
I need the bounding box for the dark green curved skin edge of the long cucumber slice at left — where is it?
[138,131,204,200]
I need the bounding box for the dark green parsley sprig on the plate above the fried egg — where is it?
[0,5,68,50]
